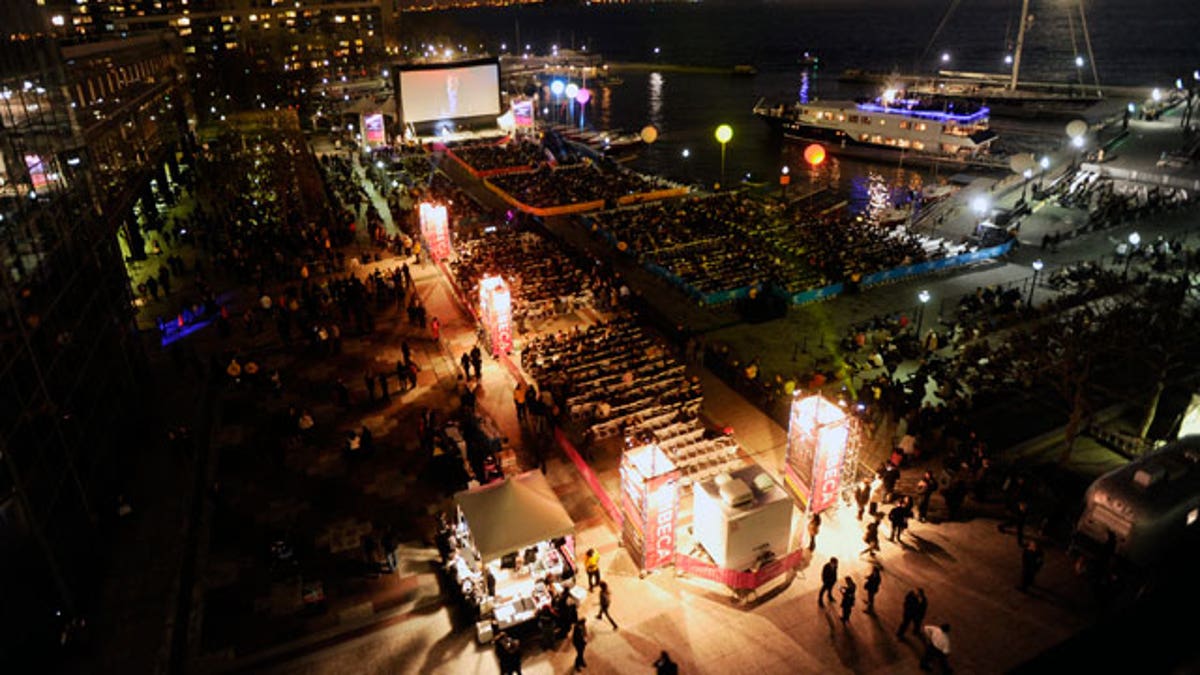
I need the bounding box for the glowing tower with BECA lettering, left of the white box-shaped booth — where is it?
[620,444,679,572]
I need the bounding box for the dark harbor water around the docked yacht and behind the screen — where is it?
[404,0,1200,195]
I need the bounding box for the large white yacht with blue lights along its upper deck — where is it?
[754,91,1003,166]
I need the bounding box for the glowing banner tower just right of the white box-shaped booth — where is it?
[785,395,858,513]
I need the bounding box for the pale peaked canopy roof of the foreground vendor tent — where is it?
[454,471,575,562]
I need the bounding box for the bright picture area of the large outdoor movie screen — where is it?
[400,64,500,123]
